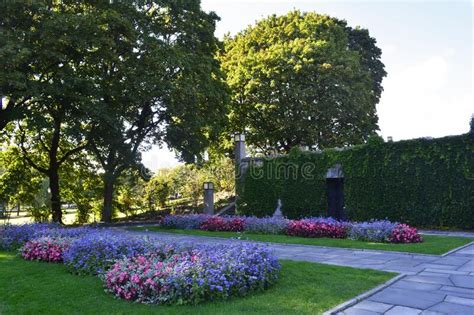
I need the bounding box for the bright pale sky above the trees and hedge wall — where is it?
[143,0,474,170]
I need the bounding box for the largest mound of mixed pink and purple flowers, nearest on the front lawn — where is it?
[102,244,280,304]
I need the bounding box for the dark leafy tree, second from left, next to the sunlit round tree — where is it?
[87,0,227,222]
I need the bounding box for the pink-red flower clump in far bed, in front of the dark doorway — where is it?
[287,218,347,238]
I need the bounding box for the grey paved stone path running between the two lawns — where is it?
[121,231,474,315]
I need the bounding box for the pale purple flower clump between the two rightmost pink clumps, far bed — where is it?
[348,220,398,242]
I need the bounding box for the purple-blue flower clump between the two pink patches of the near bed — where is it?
[64,231,156,274]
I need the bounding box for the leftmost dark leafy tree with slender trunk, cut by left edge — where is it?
[0,1,116,222]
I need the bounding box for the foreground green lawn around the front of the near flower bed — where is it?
[0,252,394,315]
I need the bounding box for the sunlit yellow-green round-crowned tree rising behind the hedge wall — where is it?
[219,11,386,152]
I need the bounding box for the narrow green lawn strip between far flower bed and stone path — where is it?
[130,226,474,255]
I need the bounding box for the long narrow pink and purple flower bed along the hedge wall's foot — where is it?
[160,214,423,243]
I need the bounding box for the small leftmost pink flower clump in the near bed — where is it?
[20,236,72,262]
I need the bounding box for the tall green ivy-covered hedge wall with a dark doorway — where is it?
[237,134,474,229]
